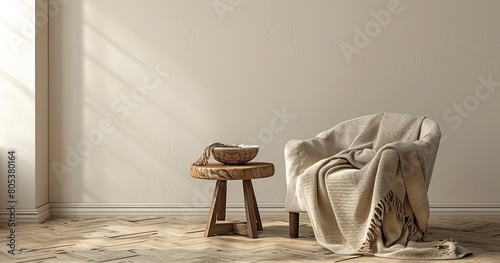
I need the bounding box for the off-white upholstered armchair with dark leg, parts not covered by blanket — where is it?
[284,114,441,238]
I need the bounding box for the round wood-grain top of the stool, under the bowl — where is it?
[190,162,274,180]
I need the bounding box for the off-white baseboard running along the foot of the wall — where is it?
[0,203,500,224]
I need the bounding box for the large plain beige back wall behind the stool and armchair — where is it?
[49,0,500,217]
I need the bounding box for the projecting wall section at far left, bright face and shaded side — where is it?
[0,0,49,223]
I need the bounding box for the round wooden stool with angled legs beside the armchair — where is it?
[190,162,274,238]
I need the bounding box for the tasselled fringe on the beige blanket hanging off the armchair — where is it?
[359,191,427,254]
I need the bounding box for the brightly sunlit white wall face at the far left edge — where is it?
[0,1,39,208]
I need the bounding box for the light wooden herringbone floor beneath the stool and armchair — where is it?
[0,215,500,263]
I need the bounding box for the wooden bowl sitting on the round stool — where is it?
[212,144,259,165]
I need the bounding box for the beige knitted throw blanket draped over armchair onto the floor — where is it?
[298,113,470,259]
